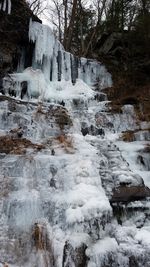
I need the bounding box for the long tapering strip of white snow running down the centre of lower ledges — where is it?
[48,134,111,224]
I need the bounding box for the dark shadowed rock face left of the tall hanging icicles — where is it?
[0,0,40,79]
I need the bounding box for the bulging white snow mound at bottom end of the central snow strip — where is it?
[66,184,111,224]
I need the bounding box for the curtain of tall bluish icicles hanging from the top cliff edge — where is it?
[23,20,112,88]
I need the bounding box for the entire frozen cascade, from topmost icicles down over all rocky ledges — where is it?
[0,22,150,267]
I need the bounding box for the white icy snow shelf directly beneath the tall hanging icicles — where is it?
[12,68,94,101]
